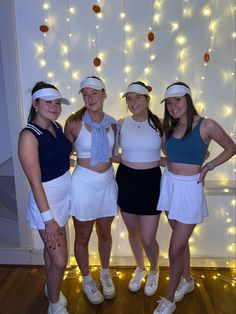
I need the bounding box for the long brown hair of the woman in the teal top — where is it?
[163,82,198,138]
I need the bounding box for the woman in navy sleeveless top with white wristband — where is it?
[18,82,72,314]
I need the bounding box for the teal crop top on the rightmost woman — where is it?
[164,118,208,166]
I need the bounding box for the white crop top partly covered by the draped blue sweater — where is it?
[74,121,115,158]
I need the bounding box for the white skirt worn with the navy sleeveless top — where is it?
[28,171,71,230]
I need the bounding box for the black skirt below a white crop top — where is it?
[116,164,161,215]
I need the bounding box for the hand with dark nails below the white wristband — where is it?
[44,219,62,250]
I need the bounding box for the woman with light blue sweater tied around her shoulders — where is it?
[65,76,117,304]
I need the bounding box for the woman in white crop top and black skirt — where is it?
[116,81,165,296]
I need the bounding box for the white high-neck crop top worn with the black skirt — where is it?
[120,117,161,162]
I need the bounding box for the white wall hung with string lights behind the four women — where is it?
[8,0,235,264]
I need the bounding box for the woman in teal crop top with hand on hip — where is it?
[154,82,236,314]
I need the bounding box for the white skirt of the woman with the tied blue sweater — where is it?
[70,166,117,221]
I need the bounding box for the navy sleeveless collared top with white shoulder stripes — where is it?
[24,122,72,182]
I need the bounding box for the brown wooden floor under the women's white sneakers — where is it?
[0,266,236,314]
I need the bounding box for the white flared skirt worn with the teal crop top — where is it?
[157,168,208,224]
